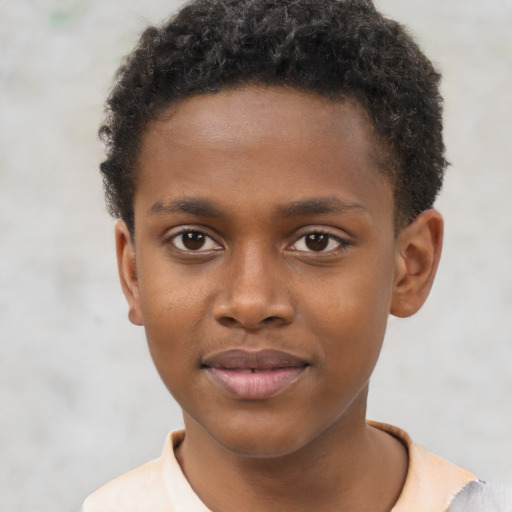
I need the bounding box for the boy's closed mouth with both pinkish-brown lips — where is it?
[201,349,310,400]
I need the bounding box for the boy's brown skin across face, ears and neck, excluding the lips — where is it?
[116,86,443,512]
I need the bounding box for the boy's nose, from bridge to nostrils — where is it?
[213,246,295,330]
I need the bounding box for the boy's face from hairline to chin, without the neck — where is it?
[118,87,404,457]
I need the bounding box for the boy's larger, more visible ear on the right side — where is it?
[390,210,443,317]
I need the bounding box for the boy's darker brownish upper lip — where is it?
[201,349,309,370]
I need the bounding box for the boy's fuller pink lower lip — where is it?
[207,366,306,400]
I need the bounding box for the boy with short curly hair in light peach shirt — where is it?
[83,0,490,512]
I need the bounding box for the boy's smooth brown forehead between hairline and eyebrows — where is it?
[135,86,391,222]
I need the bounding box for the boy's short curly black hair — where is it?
[100,0,447,233]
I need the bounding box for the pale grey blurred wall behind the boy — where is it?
[0,0,512,512]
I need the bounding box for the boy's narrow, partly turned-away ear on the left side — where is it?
[115,220,144,325]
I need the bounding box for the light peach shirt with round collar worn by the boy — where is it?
[82,422,477,512]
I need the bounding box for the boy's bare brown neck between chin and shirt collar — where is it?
[176,394,407,512]
